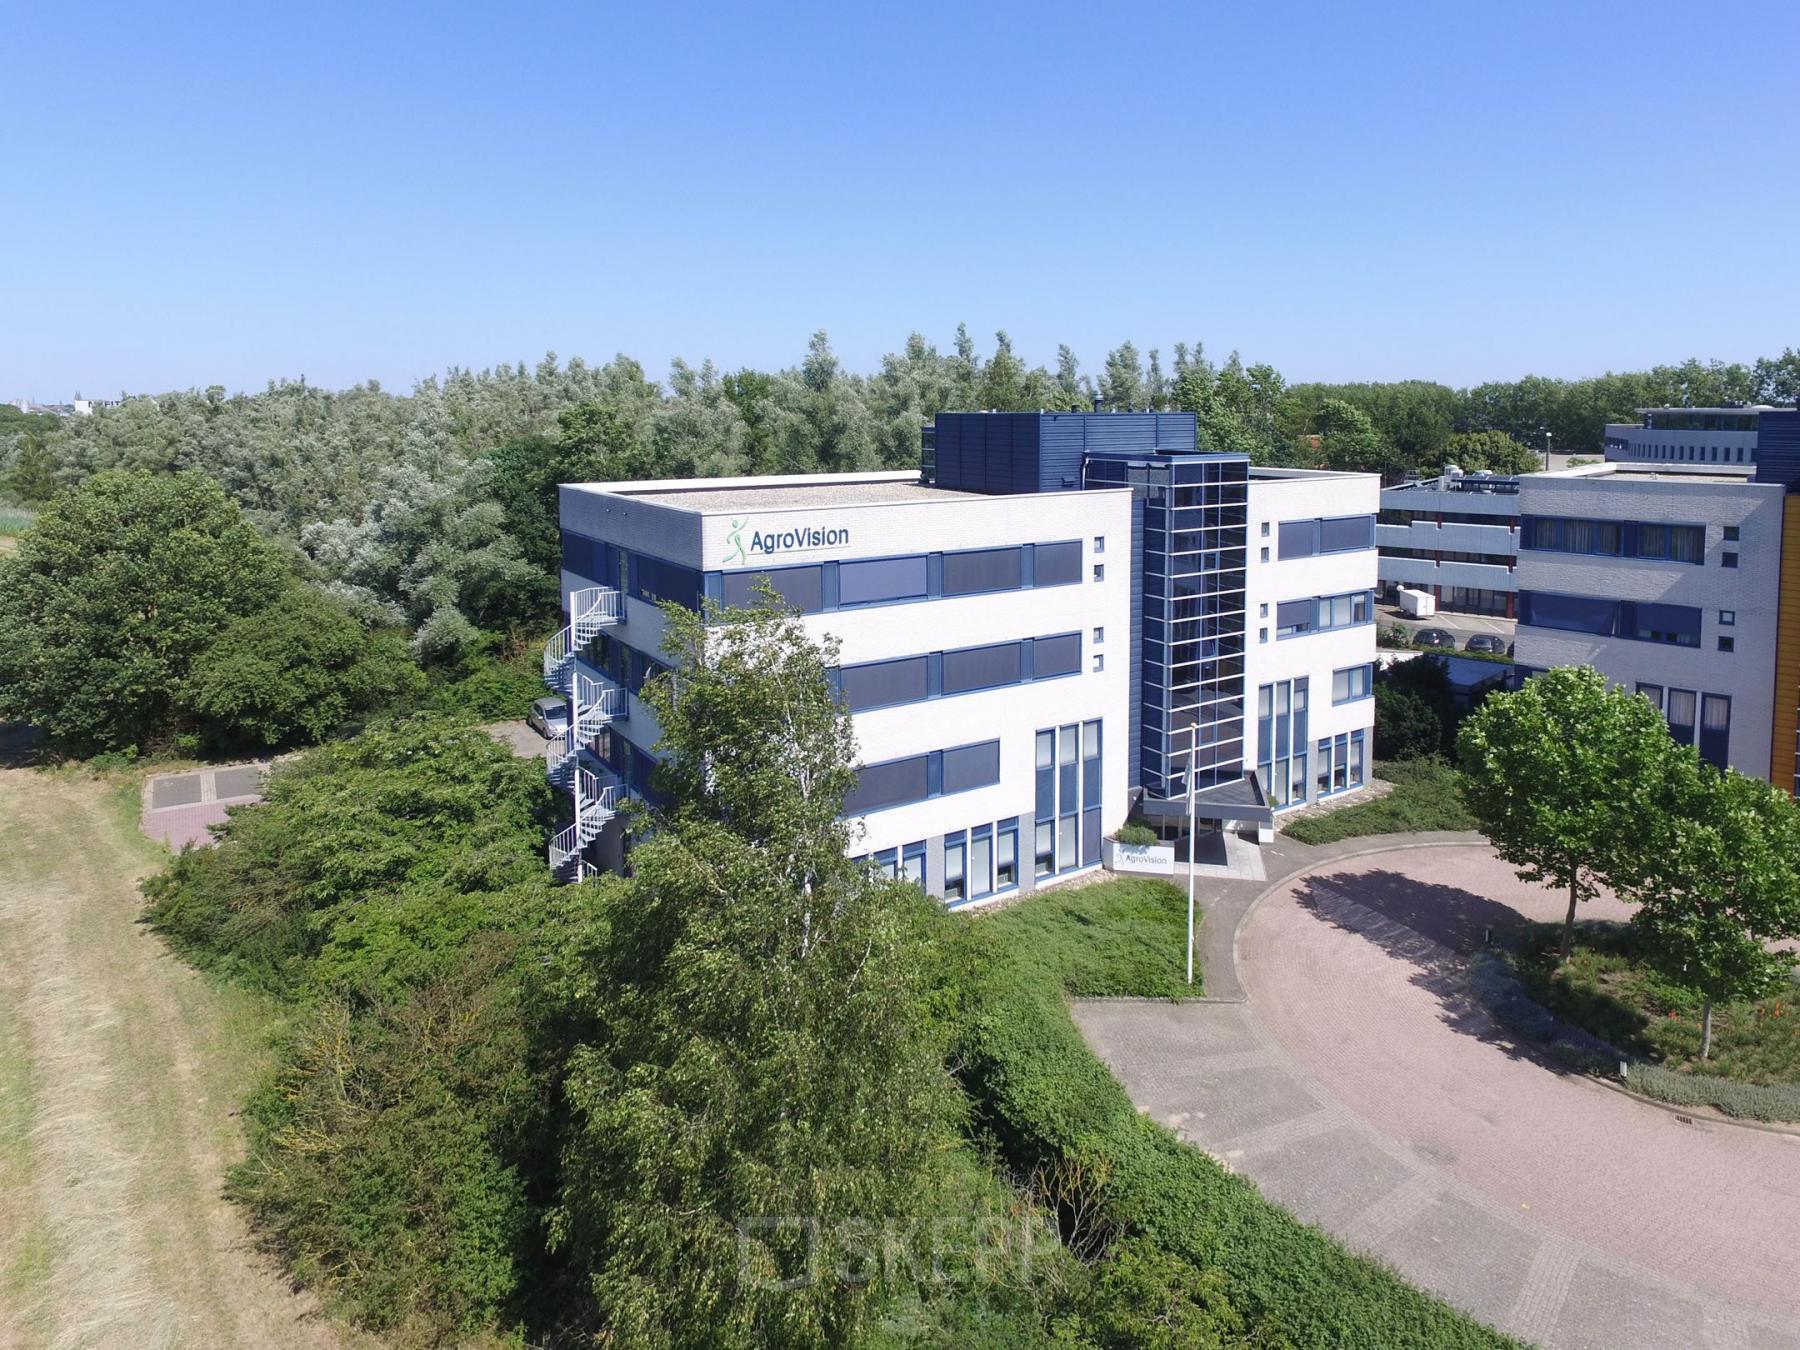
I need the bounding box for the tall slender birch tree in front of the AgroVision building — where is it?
[553,608,959,1345]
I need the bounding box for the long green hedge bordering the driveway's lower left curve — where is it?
[963,934,1514,1346]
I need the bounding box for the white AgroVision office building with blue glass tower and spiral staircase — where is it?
[545,412,1377,905]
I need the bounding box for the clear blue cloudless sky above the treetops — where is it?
[0,0,1800,400]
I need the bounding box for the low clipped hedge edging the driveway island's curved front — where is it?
[1472,952,1800,1121]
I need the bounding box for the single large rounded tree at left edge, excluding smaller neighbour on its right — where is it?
[0,472,290,752]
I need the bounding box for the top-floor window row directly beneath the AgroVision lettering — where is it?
[718,536,1080,614]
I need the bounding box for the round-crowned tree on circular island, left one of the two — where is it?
[1458,666,1683,959]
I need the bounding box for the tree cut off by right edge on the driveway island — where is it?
[1625,756,1800,1058]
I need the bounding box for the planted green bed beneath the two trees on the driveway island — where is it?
[1517,923,1800,1084]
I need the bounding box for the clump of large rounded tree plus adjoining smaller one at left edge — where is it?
[0,472,419,754]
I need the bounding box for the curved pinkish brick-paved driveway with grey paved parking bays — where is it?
[1076,844,1800,1350]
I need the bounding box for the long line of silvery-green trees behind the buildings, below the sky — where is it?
[0,328,1800,676]
